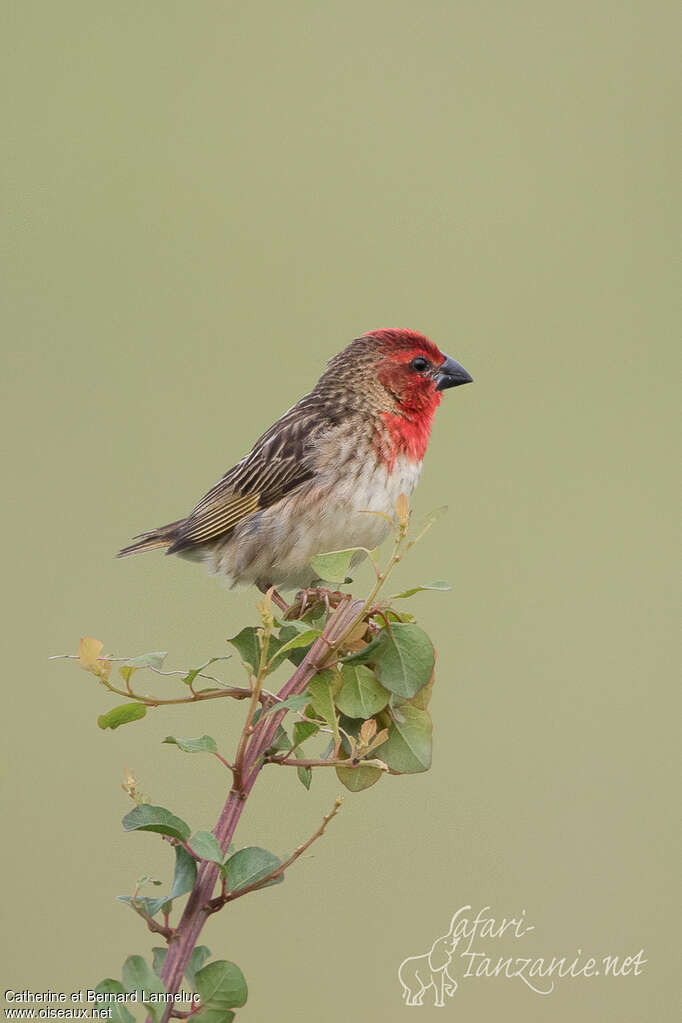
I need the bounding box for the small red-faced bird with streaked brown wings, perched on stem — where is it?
[118,327,472,593]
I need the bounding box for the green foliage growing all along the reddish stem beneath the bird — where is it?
[62,497,450,1023]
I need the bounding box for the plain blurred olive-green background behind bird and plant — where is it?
[0,0,680,1023]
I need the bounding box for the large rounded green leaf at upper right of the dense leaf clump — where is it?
[345,622,435,700]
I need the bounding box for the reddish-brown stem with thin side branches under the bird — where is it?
[92,495,428,1023]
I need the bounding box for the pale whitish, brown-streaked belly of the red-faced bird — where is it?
[204,456,421,589]
